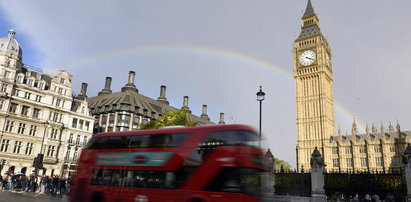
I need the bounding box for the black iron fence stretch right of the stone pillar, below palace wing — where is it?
[324,173,407,201]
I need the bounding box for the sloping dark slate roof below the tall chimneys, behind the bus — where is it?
[88,90,214,125]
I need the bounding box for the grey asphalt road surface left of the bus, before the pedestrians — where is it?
[0,191,68,202]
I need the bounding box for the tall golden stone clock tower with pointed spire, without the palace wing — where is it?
[293,0,335,170]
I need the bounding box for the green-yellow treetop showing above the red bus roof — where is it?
[140,109,198,130]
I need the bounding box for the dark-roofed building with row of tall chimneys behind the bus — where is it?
[89,71,224,132]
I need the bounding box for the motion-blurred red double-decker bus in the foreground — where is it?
[70,125,265,202]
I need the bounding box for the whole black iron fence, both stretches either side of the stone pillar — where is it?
[274,172,407,201]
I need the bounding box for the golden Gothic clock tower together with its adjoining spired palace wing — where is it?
[293,0,411,172]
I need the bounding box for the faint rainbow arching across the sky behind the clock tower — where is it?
[46,45,365,132]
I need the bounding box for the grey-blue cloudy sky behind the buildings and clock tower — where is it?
[0,0,411,166]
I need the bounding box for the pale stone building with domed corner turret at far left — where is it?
[0,30,94,176]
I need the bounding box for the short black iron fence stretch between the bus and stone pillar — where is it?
[274,171,311,197]
